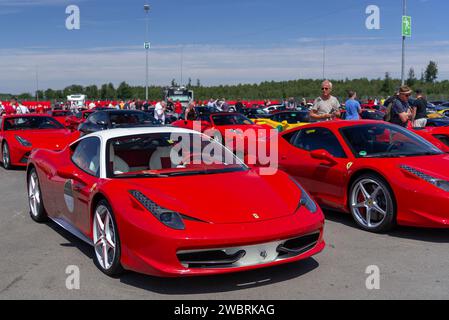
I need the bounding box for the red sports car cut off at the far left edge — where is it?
[0,115,79,169]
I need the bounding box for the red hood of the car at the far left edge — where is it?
[14,129,76,150]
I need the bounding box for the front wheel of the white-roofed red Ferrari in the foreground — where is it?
[92,199,123,277]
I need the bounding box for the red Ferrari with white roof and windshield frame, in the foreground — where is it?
[27,127,325,277]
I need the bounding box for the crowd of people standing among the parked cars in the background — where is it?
[0,80,427,128]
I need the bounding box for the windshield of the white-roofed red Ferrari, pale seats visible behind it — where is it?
[106,132,248,178]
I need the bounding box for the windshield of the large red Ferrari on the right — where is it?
[340,123,442,158]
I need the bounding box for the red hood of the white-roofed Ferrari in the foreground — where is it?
[122,170,301,224]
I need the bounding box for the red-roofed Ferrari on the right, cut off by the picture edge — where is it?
[279,120,449,232]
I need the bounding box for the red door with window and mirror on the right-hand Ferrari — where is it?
[279,127,350,209]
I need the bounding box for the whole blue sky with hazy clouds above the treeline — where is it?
[0,0,449,93]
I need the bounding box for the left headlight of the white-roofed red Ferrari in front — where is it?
[129,190,185,230]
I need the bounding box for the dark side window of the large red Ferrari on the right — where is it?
[292,128,346,158]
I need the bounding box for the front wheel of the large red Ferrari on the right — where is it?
[348,174,396,233]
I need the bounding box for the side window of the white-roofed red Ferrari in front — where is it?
[72,137,100,177]
